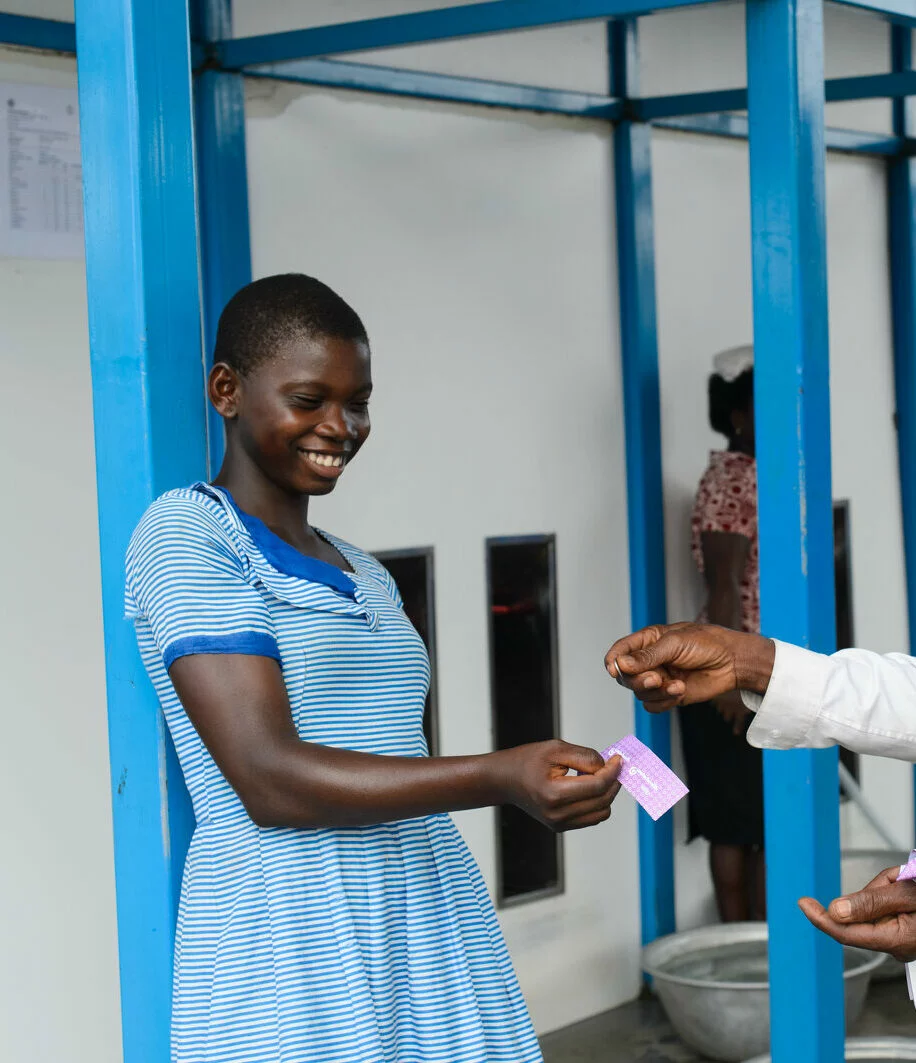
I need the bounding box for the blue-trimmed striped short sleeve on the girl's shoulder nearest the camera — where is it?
[125,495,281,669]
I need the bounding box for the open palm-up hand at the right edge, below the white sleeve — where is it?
[798,867,916,963]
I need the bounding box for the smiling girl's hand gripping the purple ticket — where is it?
[492,740,623,831]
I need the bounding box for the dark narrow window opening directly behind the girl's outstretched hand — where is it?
[487,535,563,906]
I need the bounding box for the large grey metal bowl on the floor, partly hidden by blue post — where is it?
[643,923,883,1063]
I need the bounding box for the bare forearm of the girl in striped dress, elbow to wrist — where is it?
[237,739,511,829]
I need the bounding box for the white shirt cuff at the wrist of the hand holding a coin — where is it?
[742,639,830,749]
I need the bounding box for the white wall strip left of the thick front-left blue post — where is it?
[0,43,121,1063]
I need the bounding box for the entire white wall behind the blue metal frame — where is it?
[0,0,913,1063]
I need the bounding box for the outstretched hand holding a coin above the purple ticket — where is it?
[605,624,775,712]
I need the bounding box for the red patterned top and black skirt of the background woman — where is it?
[678,451,763,846]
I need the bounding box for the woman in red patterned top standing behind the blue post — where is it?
[679,347,766,923]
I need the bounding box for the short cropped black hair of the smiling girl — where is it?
[214,273,369,376]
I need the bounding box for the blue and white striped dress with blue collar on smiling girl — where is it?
[126,484,541,1063]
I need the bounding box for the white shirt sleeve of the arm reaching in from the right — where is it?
[742,642,916,762]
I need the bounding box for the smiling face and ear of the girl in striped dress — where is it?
[209,335,372,495]
